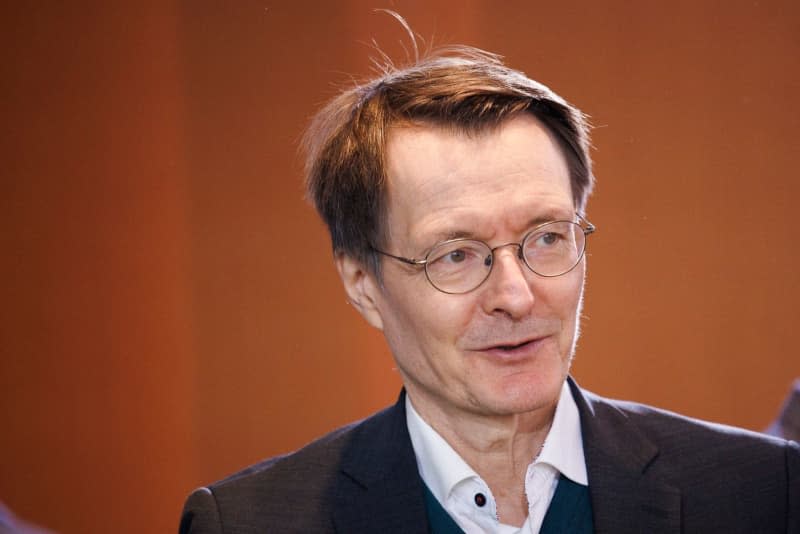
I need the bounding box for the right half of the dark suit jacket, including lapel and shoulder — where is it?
[571,383,800,533]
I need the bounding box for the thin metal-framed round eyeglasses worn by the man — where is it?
[373,213,595,294]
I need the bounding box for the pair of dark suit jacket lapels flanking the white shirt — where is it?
[324,379,681,534]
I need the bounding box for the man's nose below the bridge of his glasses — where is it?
[483,246,535,319]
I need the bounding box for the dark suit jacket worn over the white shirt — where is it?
[180,380,800,534]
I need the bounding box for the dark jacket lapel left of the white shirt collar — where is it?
[334,392,428,533]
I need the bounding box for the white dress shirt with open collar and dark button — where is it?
[406,382,588,534]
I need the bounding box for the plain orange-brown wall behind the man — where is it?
[0,0,800,533]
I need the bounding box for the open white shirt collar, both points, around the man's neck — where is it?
[405,382,588,508]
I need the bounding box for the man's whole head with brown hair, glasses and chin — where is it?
[308,49,592,421]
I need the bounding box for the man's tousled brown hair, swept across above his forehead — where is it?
[304,46,594,274]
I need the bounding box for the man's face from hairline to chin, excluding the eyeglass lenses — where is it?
[354,115,585,417]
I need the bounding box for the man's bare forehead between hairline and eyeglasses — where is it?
[386,115,574,244]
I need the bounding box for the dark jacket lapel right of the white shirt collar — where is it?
[569,378,681,534]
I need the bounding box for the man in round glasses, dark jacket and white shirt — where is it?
[181,48,800,533]
